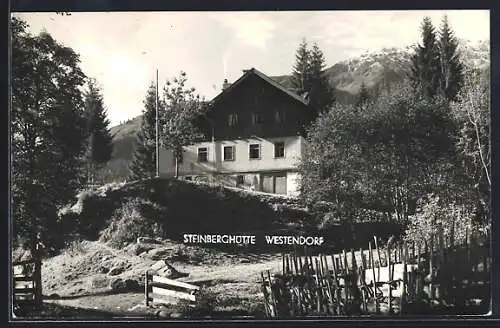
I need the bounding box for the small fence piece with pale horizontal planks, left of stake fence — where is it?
[144,271,200,306]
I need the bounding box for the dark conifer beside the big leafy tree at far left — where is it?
[84,79,113,183]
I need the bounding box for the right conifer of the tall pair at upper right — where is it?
[438,16,464,101]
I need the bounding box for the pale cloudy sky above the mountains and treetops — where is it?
[16,10,490,125]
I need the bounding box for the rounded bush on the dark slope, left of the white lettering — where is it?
[100,198,164,248]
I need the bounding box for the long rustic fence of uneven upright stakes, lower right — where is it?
[261,228,491,318]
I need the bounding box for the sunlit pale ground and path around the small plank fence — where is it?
[43,242,281,317]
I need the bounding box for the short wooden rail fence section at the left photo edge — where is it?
[12,260,42,307]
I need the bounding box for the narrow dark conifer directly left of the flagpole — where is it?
[130,82,163,180]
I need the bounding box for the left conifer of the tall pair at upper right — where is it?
[410,17,441,97]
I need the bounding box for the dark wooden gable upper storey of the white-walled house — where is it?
[201,69,308,140]
